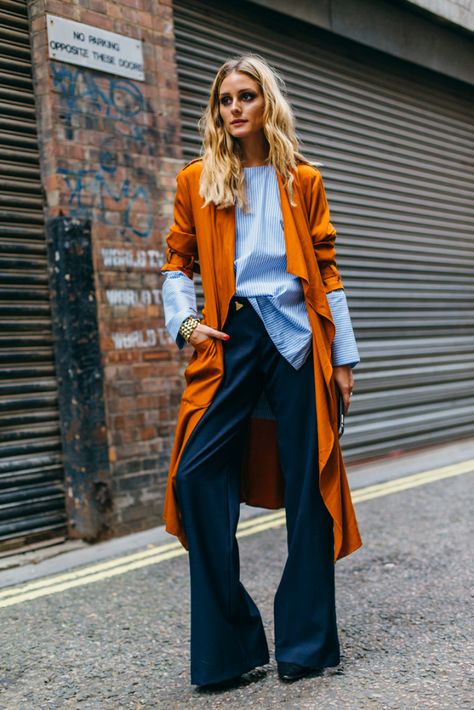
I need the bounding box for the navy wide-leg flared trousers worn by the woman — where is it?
[176,299,339,685]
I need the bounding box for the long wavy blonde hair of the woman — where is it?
[199,54,309,210]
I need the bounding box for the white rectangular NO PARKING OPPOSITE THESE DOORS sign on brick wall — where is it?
[47,15,145,81]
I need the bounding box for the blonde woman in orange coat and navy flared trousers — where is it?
[162,54,361,686]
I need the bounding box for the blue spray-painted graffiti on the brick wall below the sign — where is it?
[52,63,156,238]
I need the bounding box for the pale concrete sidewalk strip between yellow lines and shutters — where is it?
[0,438,474,588]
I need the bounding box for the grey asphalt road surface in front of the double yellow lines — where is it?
[0,474,474,710]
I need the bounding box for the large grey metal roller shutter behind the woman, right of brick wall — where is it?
[174,0,474,460]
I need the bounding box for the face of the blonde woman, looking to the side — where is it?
[219,72,265,140]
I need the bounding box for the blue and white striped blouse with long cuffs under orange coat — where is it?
[163,165,359,369]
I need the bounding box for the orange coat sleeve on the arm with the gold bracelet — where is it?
[161,171,199,279]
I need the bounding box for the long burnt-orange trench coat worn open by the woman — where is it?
[162,159,362,560]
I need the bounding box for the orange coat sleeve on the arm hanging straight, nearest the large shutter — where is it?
[308,171,344,293]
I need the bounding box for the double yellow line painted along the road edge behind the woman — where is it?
[0,459,474,608]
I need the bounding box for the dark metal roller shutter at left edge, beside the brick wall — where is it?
[0,0,66,551]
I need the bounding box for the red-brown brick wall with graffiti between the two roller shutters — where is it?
[29,0,187,534]
